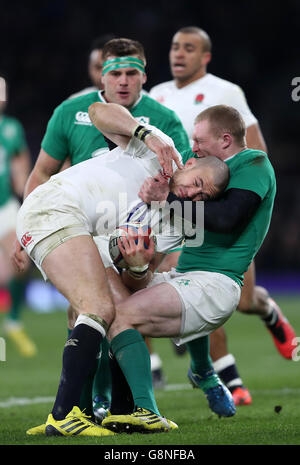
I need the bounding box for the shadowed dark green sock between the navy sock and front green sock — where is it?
[93,338,111,403]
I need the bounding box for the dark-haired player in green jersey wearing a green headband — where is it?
[16,38,190,420]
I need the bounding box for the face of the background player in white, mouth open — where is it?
[169,32,211,84]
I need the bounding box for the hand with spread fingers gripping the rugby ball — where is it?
[118,228,155,269]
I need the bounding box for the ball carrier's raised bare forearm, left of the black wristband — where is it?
[89,102,137,137]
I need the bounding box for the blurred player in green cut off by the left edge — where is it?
[0,78,37,357]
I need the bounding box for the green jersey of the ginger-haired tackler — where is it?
[176,149,276,286]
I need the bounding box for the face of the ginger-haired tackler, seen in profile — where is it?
[192,120,224,160]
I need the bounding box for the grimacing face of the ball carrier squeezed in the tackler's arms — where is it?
[170,158,217,200]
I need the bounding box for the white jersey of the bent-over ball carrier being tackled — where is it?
[23,125,181,252]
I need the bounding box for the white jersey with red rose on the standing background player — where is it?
[149,73,257,144]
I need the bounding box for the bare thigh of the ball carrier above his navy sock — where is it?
[42,235,114,325]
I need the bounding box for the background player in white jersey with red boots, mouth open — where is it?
[150,26,295,405]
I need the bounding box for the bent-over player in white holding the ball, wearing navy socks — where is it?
[17,102,228,436]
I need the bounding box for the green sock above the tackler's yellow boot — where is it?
[111,329,160,415]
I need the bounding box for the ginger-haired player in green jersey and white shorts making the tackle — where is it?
[96,105,276,432]
